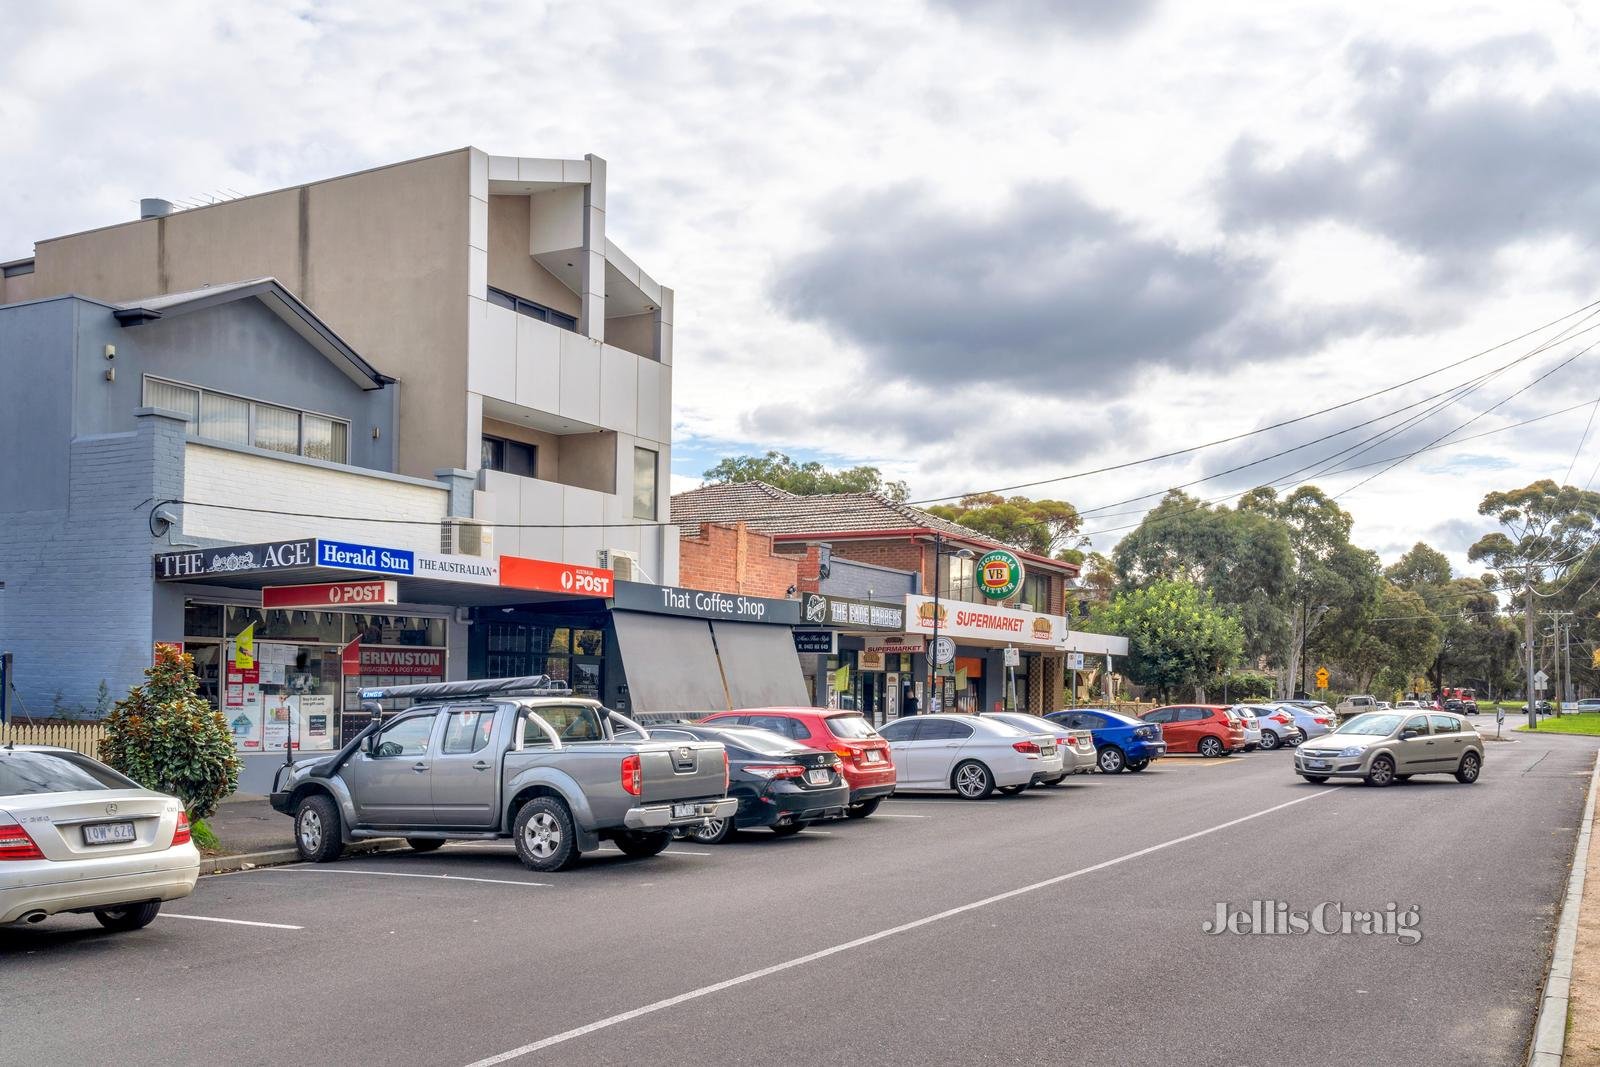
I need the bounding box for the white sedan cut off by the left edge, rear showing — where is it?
[0,745,200,929]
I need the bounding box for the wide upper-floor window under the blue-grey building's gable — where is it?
[144,376,350,464]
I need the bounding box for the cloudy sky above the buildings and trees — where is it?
[0,0,1600,575]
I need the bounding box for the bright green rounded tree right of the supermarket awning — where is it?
[1088,581,1245,701]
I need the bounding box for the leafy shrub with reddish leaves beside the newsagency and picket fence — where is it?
[101,645,240,822]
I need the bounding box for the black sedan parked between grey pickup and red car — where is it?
[650,723,850,845]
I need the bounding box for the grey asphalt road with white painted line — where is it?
[0,737,1597,1067]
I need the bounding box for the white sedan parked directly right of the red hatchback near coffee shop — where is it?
[878,713,1062,800]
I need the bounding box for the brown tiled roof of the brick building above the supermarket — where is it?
[672,482,1070,566]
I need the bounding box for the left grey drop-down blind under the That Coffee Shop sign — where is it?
[611,611,729,715]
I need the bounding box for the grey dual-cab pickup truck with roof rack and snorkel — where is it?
[270,675,739,872]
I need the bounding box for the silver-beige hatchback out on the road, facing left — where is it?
[1294,712,1483,785]
